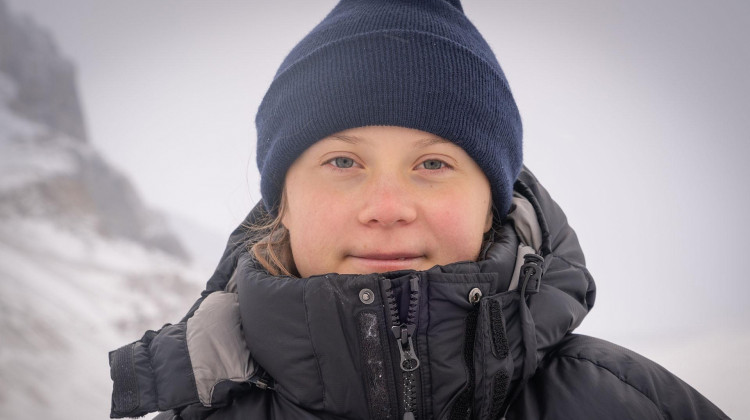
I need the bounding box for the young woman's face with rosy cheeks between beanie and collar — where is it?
[282,126,492,277]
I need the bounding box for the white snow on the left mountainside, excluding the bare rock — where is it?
[0,67,210,419]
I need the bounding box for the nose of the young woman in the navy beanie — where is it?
[358,177,417,227]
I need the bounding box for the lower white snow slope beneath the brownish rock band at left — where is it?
[0,218,205,419]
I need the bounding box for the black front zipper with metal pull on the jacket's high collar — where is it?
[384,276,419,420]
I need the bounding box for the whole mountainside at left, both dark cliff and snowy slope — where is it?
[0,0,214,419]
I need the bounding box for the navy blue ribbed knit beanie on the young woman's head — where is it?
[255,0,522,217]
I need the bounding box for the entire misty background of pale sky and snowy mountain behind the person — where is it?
[0,0,750,419]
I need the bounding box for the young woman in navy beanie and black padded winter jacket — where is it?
[110,0,726,419]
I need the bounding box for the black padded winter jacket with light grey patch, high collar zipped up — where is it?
[110,169,727,420]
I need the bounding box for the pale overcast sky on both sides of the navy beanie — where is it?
[9,0,750,418]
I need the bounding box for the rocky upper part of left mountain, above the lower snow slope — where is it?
[0,1,188,259]
